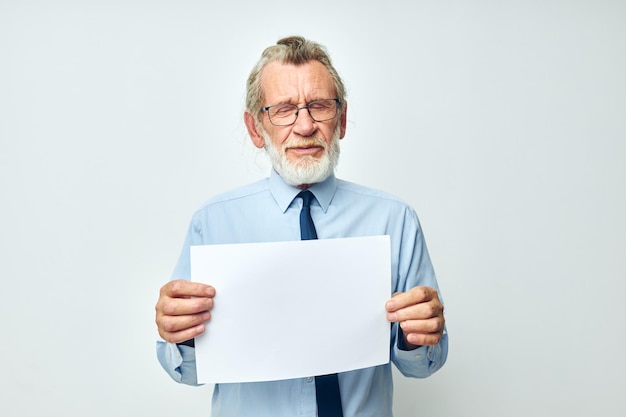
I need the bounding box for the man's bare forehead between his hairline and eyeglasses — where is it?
[261,60,335,100]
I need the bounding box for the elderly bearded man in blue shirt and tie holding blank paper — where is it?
[156,37,448,417]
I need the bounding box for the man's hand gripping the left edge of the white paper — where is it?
[155,280,215,343]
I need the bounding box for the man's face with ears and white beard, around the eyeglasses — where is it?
[246,61,346,186]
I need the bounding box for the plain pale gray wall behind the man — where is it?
[0,0,626,417]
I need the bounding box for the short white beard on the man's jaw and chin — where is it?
[261,126,340,187]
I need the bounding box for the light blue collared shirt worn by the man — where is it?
[157,172,448,417]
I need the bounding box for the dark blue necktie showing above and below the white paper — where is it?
[298,190,343,417]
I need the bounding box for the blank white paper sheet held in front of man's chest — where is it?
[191,236,391,383]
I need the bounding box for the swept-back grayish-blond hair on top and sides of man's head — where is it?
[246,36,346,120]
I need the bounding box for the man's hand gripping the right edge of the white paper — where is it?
[385,286,446,350]
